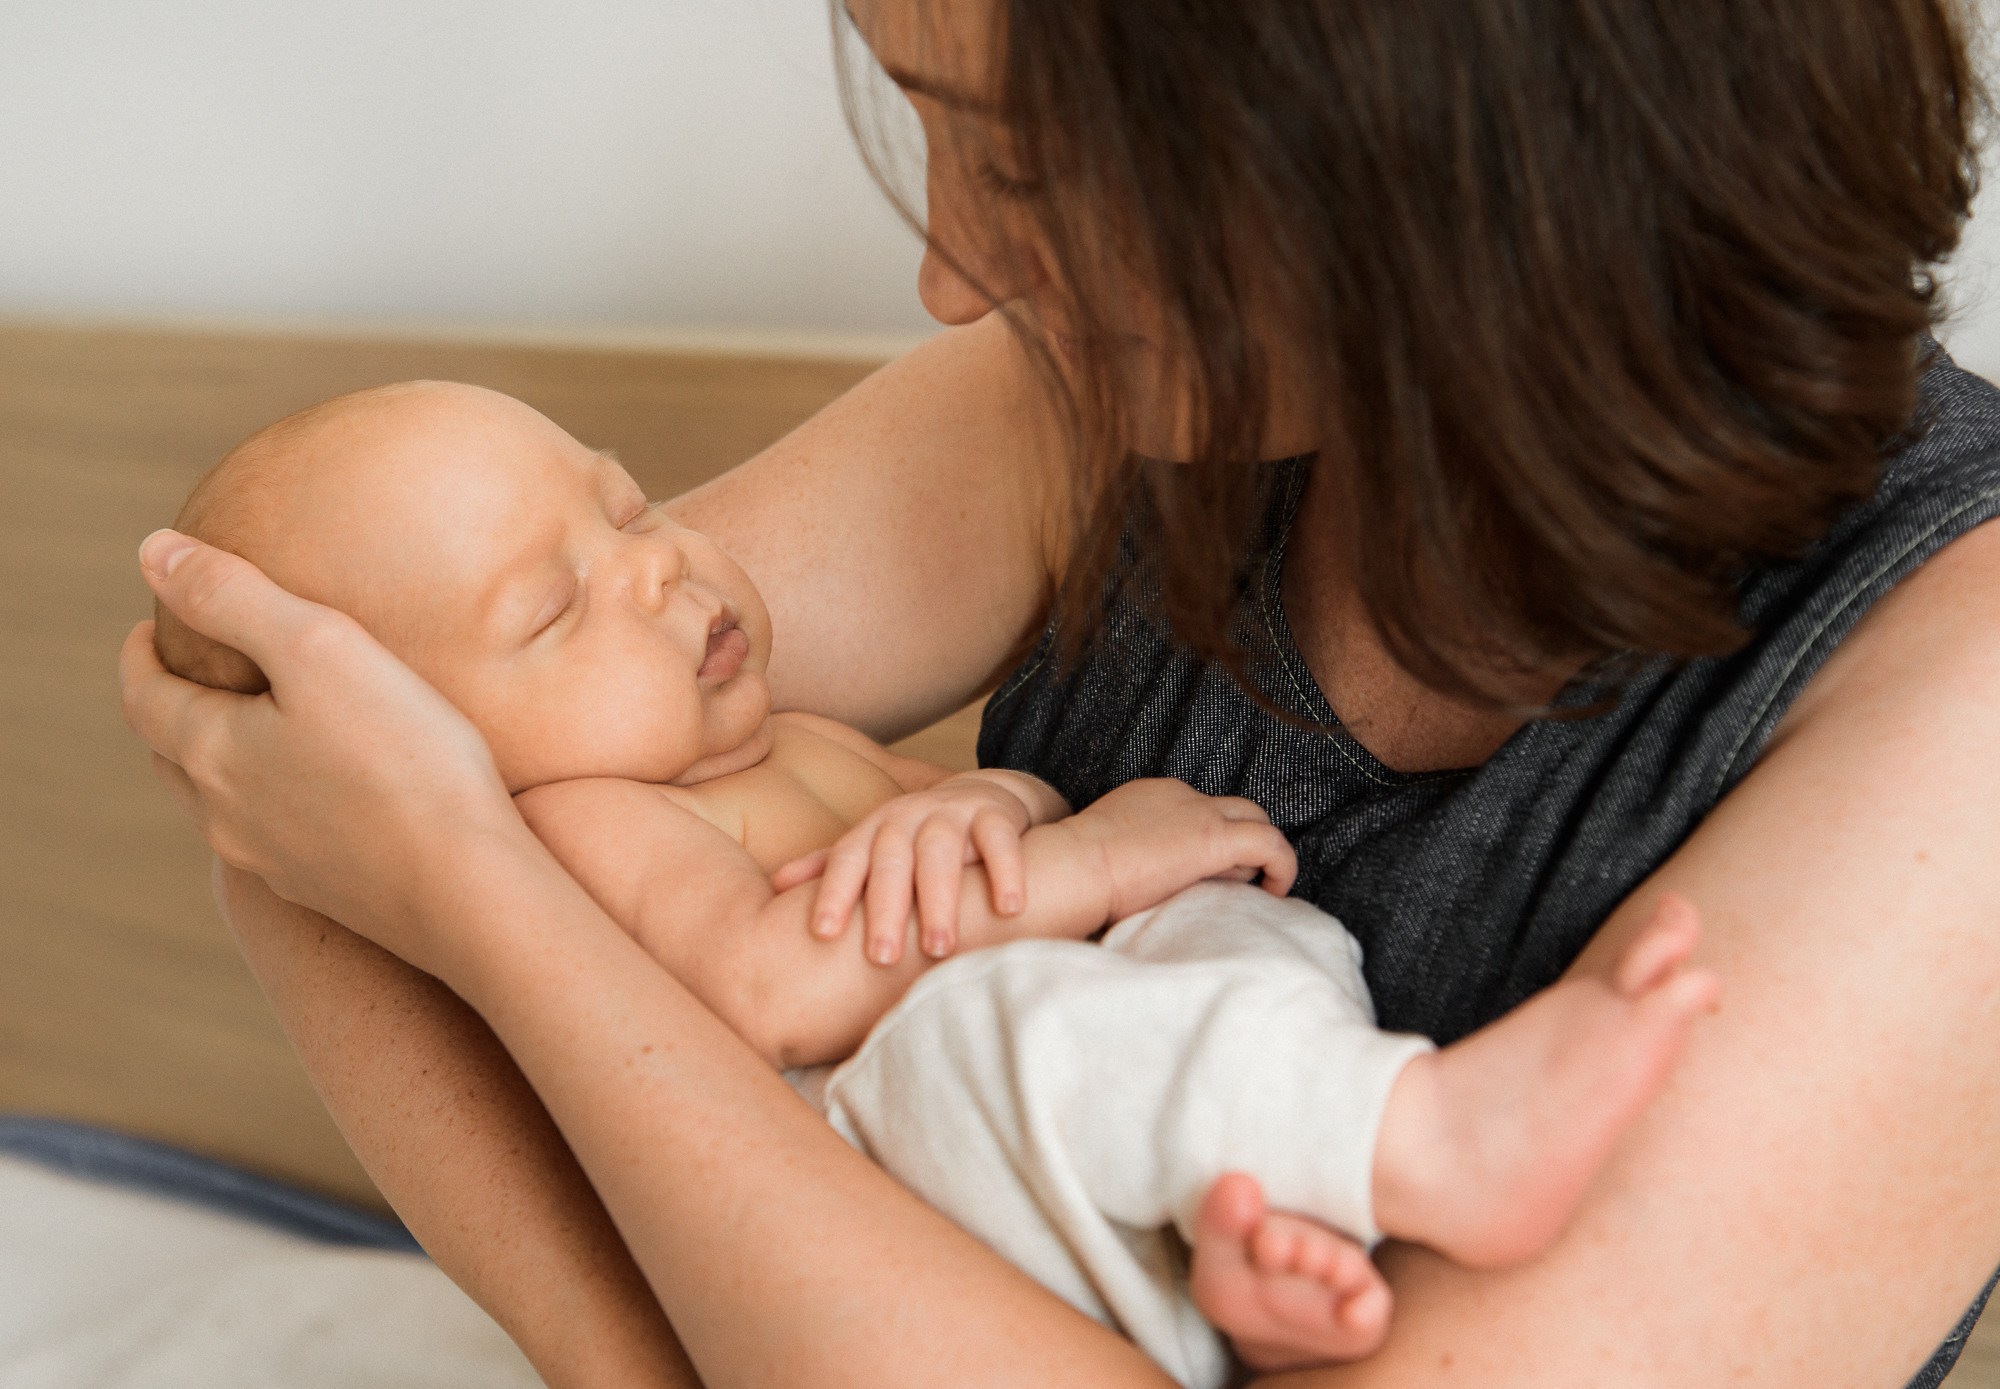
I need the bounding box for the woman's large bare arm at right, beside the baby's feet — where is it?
[1286,524,2000,1389]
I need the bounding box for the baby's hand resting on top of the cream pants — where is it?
[1062,777,1298,921]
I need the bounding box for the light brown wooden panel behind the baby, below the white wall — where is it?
[0,324,974,1203]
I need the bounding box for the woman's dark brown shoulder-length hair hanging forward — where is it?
[850,0,1982,705]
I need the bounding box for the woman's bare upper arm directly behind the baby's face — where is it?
[672,314,1070,743]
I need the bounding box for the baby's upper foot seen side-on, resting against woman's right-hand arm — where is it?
[1374,895,1718,1269]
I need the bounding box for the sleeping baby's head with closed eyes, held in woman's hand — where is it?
[154,382,770,791]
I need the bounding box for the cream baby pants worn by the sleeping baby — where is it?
[804,883,1432,1389]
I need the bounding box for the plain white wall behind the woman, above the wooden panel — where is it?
[0,0,2000,376]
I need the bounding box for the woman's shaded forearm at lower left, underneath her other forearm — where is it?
[218,869,698,1389]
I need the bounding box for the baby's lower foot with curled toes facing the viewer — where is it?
[1188,1173,1390,1371]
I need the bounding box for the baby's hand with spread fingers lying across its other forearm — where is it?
[772,771,1068,965]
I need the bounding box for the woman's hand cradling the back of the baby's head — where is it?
[120,530,528,973]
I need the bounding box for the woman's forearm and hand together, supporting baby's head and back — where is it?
[122,494,1164,1389]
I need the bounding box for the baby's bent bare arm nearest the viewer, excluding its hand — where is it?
[516,779,1114,1067]
